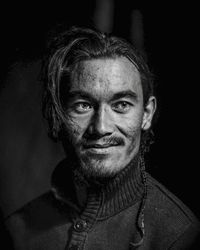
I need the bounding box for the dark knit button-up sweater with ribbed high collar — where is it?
[6,157,200,250]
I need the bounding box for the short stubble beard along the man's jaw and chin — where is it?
[62,126,140,178]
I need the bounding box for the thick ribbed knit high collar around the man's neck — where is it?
[52,155,144,219]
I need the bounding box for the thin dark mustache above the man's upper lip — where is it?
[81,136,125,147]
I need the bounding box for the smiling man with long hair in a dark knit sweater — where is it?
[6,28,199,250]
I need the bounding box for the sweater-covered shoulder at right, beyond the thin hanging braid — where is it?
[146,174,200,249]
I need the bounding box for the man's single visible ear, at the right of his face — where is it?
[142,96,157,130]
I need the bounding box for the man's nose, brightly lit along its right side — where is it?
[88,105,113,136]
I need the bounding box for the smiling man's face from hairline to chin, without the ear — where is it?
[64,57,149,177]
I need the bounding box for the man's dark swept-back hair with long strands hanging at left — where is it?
[42,27,154,143]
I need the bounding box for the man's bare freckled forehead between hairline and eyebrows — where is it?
[70,57,142,94]
